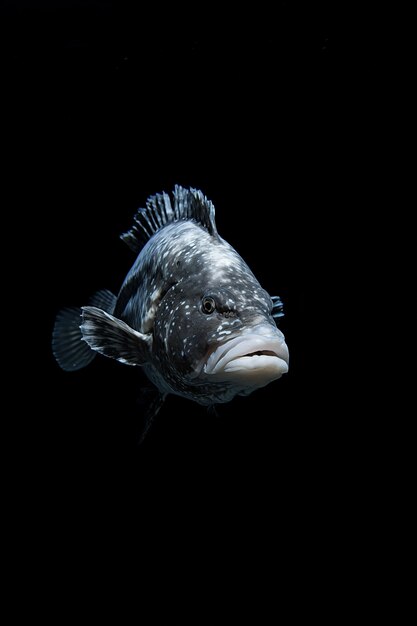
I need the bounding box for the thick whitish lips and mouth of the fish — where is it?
[203,325,289,387]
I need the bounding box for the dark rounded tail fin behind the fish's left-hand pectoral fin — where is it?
[52,289,116,372]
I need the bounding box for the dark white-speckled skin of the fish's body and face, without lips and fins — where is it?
[114,221,277,405]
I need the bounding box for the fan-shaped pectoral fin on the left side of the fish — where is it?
[80,306,152,365]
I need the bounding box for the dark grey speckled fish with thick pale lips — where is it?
[52,185,289,431]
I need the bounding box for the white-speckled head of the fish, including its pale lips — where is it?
[154,278,289,401]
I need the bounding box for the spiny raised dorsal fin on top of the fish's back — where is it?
[120,185,218,253]
